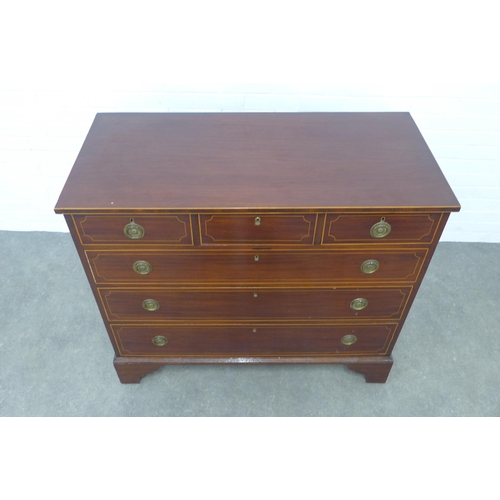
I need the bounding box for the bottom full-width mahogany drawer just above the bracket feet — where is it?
[111,324,397,357]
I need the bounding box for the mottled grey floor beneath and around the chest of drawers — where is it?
[0,231,500,416]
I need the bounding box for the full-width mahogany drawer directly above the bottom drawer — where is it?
[99,287,411,322]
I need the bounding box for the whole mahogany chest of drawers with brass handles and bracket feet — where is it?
[55,113,460,383]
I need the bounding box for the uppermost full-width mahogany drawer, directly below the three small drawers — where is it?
[86,249,427,286]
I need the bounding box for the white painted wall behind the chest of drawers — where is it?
[0,0,500,242]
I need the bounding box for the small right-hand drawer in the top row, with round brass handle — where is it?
[323,214,441,244]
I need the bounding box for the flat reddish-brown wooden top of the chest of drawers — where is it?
[55,113,460,213]
